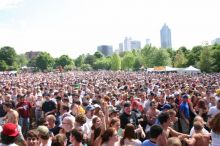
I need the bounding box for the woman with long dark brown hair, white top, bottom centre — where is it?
[120,124,141,146]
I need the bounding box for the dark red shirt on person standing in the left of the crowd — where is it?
[17,101,32,118]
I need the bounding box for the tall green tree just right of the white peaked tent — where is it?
[199,47,212,72]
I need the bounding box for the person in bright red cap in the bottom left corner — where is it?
[0,123,19,146]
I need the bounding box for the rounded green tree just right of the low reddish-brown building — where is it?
[36,52,54,71]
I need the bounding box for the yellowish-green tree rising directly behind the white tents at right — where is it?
[174,50,187,67]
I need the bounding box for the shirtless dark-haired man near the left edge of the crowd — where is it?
[3,102,19,125]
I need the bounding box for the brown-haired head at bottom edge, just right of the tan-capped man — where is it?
[51,134,67,146]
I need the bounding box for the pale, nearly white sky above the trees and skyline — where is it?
[0,0,220,58]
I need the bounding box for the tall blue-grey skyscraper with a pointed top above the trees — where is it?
[160,24,172,48]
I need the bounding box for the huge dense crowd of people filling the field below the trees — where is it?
[0,71,220,146]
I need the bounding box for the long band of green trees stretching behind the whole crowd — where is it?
[0,44,220,73]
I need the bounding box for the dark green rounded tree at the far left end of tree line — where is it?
[0,47,17,66]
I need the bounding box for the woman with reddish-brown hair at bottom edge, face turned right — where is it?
[101,128,119,146]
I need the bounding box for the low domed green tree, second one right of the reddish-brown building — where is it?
[55,55,73,68]
